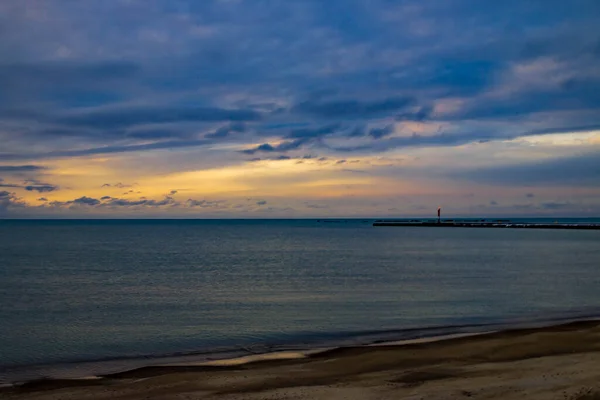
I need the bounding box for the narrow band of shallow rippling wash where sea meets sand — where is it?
[0,312,600,391]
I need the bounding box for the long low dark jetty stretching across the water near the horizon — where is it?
[373,219,600,230]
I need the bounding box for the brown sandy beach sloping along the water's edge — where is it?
[0,321,600,400]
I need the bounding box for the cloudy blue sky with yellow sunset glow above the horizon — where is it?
[0,0,600,218]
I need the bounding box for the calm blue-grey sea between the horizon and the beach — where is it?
[0,219,600,384]
